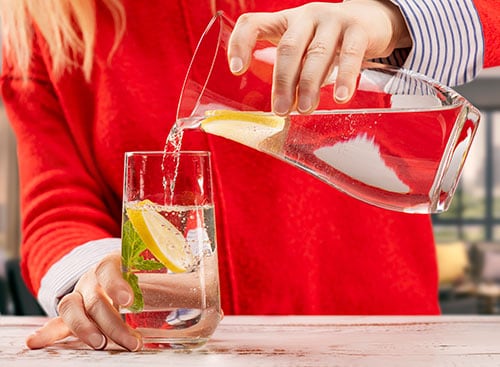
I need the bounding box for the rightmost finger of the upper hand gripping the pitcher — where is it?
[335,25,368,103]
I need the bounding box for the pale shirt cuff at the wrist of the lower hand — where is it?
[38,238,121,317]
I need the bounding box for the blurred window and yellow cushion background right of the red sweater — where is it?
[433,68,500,314]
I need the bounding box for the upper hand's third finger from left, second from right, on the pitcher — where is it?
[297,22,340,113]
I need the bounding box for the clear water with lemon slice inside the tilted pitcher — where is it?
[173,102,476,213]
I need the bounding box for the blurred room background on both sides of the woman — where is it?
[0,68,500,315]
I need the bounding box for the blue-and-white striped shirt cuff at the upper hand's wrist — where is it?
[391,0,484,86]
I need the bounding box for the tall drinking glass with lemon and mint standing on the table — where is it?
[122,151,221,348]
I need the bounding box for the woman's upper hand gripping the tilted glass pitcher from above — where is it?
[228,0,411,115]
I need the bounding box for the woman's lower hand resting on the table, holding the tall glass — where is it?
[26,254,142,351]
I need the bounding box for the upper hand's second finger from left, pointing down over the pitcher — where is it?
[273,19,315,115]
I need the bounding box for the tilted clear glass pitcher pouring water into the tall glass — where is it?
[174,13,480,213]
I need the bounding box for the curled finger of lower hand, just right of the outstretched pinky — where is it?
[58,292,107,350]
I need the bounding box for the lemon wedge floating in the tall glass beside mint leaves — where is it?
[126,200,195,273]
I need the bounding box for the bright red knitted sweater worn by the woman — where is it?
[2,0,498,314]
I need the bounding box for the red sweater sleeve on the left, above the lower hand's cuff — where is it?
[1,36,120,314]
